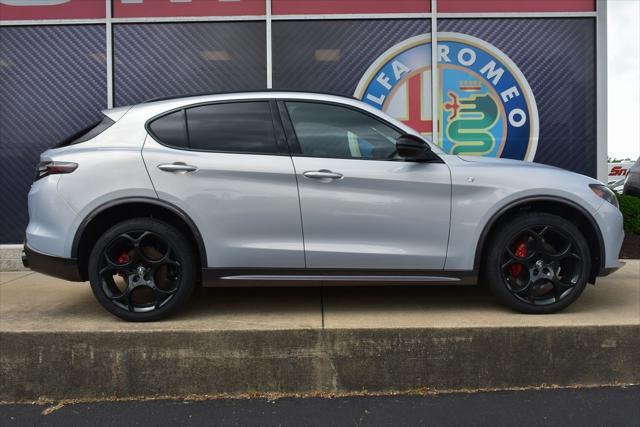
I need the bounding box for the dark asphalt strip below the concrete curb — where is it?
[0,386,640,427]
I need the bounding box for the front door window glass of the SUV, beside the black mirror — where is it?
[286,102,400,160]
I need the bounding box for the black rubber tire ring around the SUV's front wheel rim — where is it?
[485,213,591,314]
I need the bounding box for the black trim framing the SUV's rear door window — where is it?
[144,98,291,156]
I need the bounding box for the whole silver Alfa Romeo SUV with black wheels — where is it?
[23,91,623,321]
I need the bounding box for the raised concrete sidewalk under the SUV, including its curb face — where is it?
[0,260,640,400]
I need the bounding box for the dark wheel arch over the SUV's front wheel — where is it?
[473,196,605,283]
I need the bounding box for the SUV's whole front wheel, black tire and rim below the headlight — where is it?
[483,212,591,314]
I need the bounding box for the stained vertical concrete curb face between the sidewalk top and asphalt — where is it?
[0,325,640,401]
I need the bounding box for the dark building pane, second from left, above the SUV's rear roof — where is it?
[113,22,267,105]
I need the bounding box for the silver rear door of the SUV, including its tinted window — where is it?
[142,100,304,268]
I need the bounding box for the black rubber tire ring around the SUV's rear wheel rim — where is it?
[88,218,196,322]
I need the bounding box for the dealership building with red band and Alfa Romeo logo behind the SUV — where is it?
[0,0,607,245]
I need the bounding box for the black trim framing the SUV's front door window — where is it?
[278,98,444,163]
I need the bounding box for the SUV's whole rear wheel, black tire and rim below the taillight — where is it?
[88,218,196,322]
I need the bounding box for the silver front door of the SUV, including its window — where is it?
[279,100,451,270]
